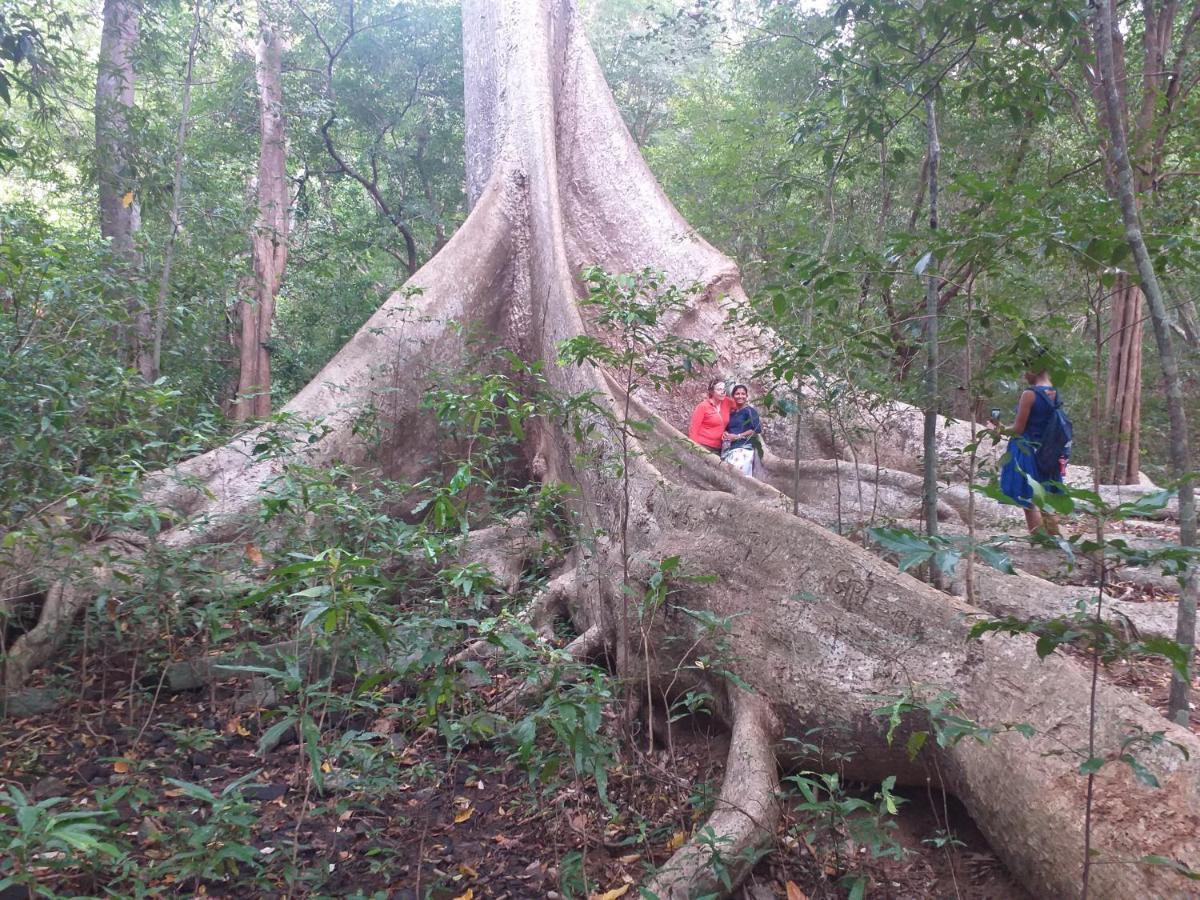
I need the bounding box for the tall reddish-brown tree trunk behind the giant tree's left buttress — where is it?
[234,0,288,421]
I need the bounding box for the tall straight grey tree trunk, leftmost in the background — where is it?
[96,0,147,380]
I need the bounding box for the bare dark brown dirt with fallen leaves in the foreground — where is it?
[9,628,1200,900]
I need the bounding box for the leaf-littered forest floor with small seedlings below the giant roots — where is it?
[0,518,1200,900]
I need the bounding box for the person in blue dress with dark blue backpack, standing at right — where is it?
[1000,370,1072,535]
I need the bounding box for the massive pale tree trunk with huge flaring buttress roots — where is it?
[6,0,1200,898]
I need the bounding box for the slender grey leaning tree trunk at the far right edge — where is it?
[1096,0,1198,724]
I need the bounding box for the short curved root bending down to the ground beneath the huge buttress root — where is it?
[646,688,780,900]
